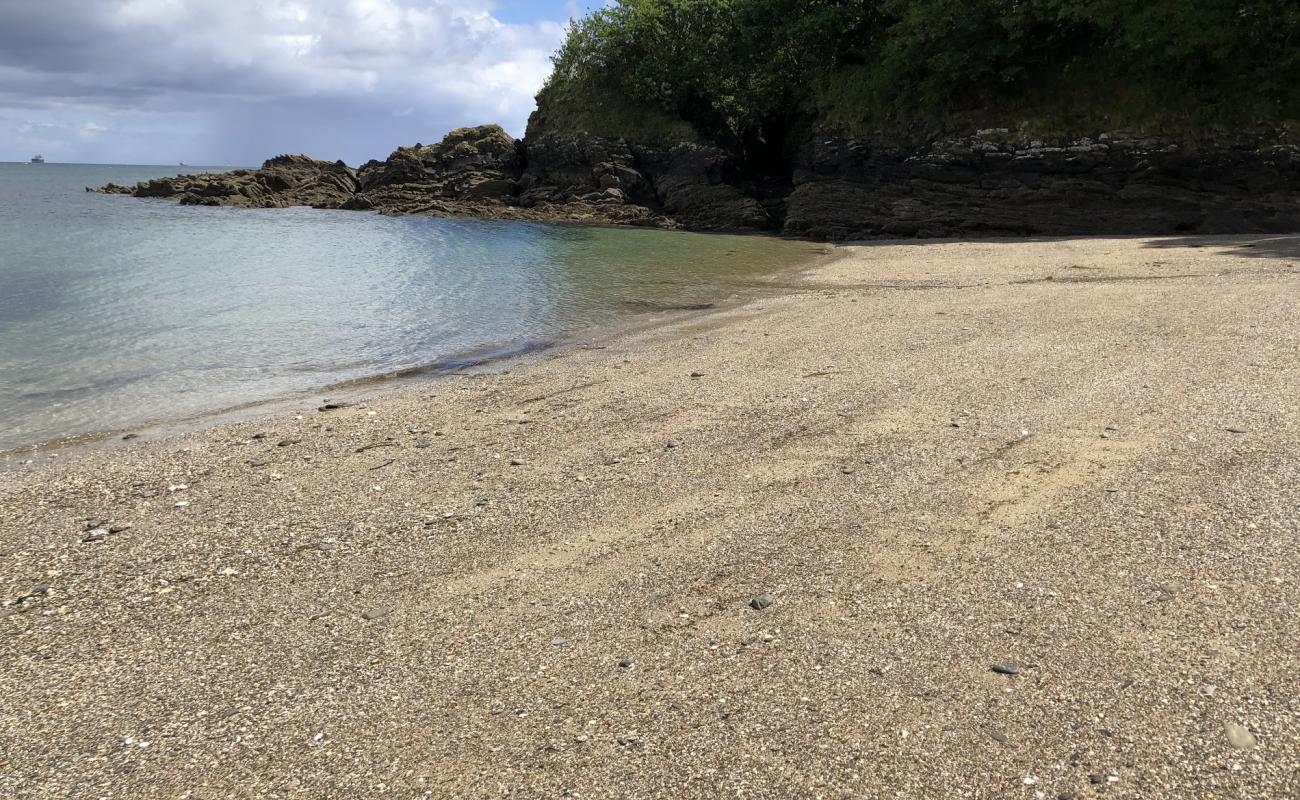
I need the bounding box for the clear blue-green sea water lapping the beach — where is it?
[0,164,814,450]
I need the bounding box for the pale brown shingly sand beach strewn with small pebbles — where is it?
[0,237,1300,799]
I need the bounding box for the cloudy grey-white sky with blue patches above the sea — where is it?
[0,0,599,165]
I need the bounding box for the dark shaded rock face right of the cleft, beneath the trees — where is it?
[785,131,1300,239]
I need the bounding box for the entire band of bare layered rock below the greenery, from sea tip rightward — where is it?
[99,125,1300,239]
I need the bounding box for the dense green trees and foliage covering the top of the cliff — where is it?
[542,0,1300,161]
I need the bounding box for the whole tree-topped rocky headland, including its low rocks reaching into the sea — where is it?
[101,0,1300,239]
